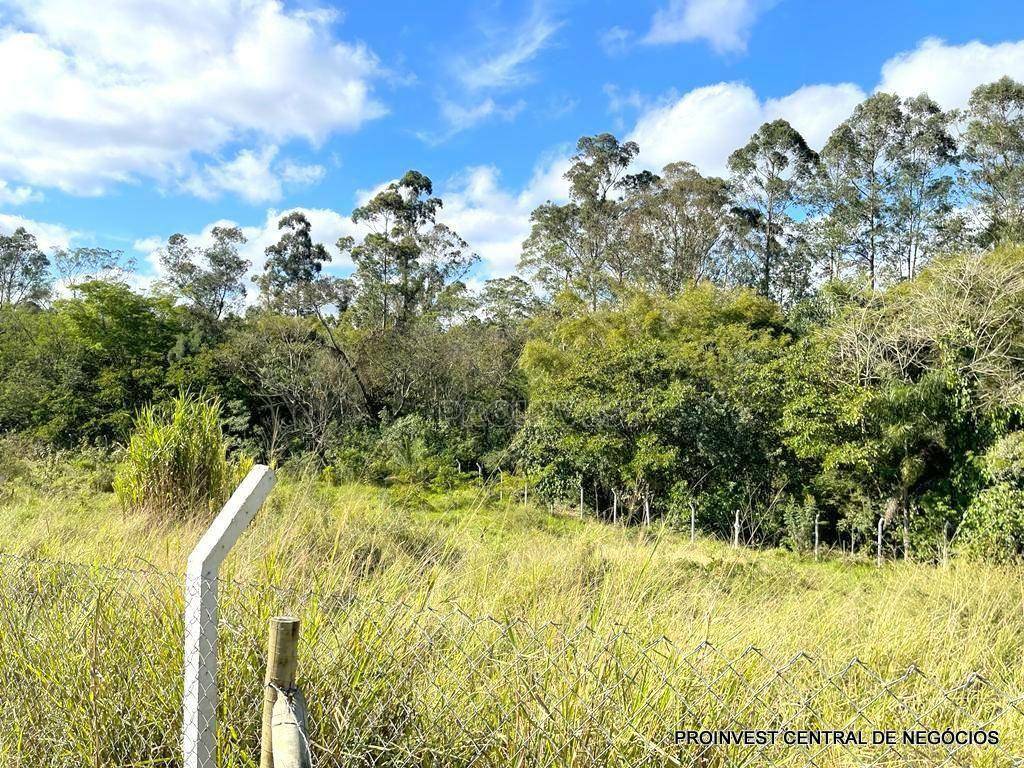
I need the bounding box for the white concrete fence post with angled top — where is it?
[181,464,274,768]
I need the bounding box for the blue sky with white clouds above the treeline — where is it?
[0,0,1024,284]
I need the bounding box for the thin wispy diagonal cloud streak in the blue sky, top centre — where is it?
[456,4,562,90]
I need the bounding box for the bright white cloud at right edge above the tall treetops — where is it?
[878,38,1024,110]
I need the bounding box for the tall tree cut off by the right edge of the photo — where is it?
[964,77,1024,244]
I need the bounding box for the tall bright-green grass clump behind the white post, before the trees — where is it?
[114,393,236,518]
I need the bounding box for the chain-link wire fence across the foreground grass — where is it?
[0,556,1024,768]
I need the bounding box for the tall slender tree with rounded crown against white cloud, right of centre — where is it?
[729,120,817,296]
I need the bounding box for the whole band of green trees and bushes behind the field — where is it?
[6,78,1024,559]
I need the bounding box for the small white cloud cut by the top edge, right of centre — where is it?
[644,0,772,53]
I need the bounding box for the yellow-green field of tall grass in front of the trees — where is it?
[0,460,1024,766]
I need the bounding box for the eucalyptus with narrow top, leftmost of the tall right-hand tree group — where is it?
[519,133,640,309]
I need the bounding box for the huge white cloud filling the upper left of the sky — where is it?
[0,0,383,194]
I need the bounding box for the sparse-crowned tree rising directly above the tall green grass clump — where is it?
[160,226,250,321]
